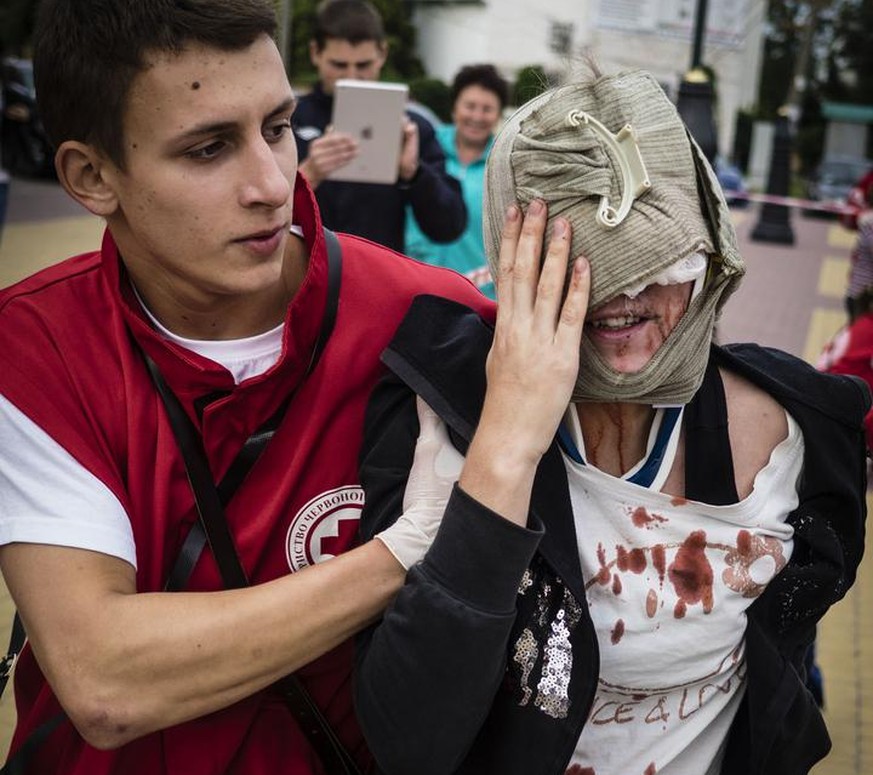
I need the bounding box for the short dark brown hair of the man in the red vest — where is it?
[34,0,276,168]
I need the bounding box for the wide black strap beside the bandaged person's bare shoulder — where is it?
[685,358,739,506]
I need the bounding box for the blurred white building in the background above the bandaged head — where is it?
[412,0,767,156]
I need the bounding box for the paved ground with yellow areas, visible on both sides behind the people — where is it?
[0,180,873,775]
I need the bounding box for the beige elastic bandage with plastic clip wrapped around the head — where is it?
[483,71,744,404]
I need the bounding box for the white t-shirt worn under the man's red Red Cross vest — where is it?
[0,306,284,568]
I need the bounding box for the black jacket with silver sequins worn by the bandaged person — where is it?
[356,297,870,775]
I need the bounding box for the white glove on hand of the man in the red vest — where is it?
[376,397,464,570]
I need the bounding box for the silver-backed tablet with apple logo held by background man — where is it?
[330,78,409,183]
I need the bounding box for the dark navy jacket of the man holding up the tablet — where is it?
[291,84,467,253]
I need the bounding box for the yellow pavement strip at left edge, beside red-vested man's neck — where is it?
[0,215,104,288]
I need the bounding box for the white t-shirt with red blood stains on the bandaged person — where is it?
[564,411,803,775]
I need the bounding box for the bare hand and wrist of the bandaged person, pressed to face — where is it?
[460,201,590,524]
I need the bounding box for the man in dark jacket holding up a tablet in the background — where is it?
[291,0,466,251]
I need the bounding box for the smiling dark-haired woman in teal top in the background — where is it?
[406,65,508,299]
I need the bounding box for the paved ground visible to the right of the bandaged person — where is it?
[719,209,873,775]
